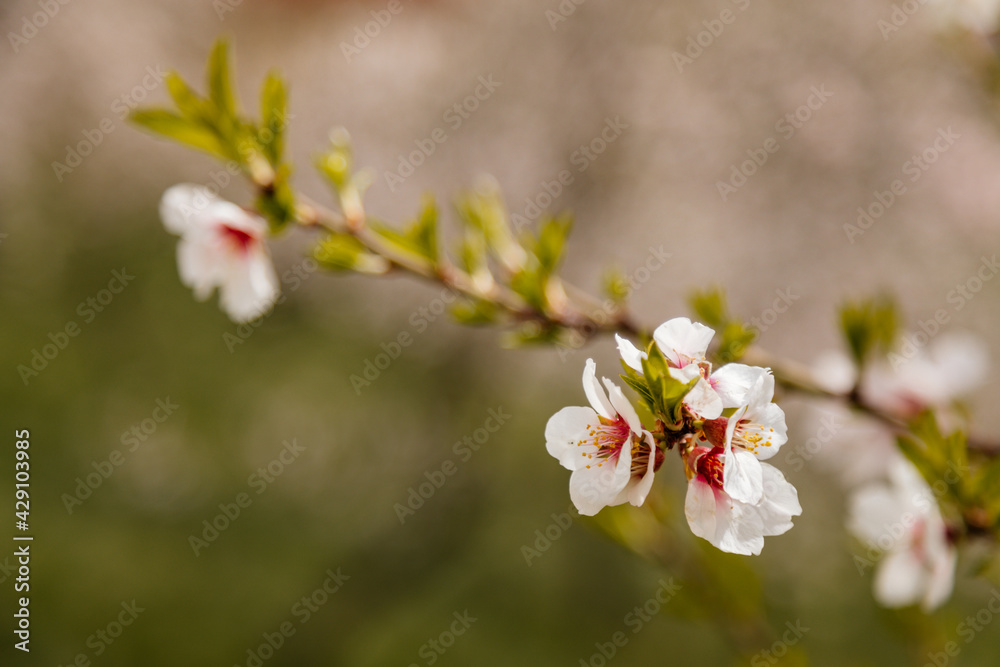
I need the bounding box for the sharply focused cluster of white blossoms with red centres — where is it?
[545,317,802,555]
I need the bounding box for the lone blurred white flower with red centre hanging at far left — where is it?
[160,184,279,322]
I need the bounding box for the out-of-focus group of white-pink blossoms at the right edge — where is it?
[815,333,989,611]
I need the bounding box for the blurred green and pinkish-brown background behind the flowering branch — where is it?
[0,0,1000,667]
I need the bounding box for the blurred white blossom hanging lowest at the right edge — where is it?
[848,454,957,611]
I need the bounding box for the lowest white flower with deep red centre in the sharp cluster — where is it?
[684,447,802,556]
